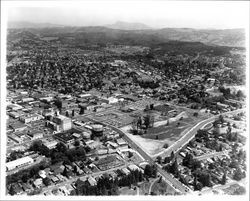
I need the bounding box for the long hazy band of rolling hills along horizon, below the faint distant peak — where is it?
[9,20,245,47]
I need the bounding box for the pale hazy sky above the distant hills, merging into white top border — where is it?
[2,0,249,29]
